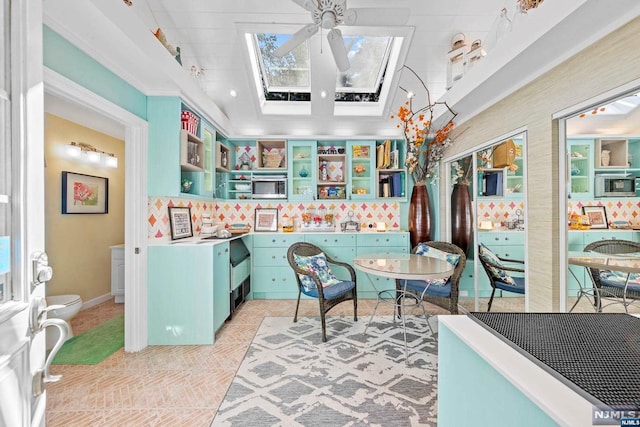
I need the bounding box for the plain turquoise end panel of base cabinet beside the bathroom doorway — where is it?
[147,244,215,345]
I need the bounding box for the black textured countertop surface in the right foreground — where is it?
[469,313,640,410]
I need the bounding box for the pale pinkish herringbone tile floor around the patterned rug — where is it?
[47,297,640,427]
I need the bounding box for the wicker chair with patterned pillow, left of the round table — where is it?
[287,242,358,342]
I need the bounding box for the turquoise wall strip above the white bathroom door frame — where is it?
[43,26,147,120]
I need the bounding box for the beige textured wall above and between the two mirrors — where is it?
[440,18,640,312]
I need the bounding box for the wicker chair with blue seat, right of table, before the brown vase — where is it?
[396,241,467,317]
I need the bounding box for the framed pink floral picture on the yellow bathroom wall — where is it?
[62,171,109,214]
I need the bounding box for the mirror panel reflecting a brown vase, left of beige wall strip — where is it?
[447,132,526,312]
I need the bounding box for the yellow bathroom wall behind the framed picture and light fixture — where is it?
[45,114,125,302]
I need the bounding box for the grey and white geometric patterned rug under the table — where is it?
[211,316,437,427]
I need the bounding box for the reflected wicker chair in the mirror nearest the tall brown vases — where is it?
[478,244,525,312]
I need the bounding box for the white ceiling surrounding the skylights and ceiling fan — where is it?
[44,0,640,139]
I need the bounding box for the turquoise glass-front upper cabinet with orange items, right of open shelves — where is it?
[347,141,376,200]
